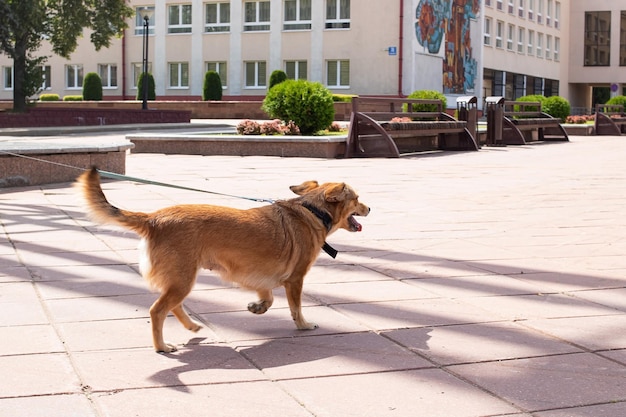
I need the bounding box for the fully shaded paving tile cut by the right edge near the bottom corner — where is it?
[449,353,626,411]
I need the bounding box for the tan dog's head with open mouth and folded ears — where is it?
[289,181,370,233]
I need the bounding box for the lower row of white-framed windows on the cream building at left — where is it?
[3,60,350,90]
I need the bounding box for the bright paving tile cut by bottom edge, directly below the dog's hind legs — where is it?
[92,381,313,417]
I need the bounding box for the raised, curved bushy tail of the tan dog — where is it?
[76,168,150,236]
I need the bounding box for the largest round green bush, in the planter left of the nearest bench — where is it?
[262,80,335,135]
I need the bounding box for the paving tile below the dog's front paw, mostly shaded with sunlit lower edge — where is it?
[237,332,432,380]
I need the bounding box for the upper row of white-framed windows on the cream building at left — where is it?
[135,0,350,35]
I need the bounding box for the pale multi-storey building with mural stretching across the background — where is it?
[0,0,626,107]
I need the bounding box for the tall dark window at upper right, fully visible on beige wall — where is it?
[585,11,611,66]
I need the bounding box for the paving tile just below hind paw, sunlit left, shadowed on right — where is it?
[74,344,264,391]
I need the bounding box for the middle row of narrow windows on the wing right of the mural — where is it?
[483,17,561,61]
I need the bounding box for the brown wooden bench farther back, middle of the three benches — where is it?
[486,97,569,145]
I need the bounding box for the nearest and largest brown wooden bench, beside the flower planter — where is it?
[345,97,478,158]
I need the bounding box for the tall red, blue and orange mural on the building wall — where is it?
[415,0,480,94]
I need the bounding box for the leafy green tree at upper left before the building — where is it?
[0,0,135,112]
